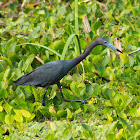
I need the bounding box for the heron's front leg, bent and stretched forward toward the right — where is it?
[57,82,91,104]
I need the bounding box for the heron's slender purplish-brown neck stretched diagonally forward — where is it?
[74,40,99,65]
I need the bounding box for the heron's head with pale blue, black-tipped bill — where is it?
[97,37,122,53]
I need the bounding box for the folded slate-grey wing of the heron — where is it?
[15,61,64,87]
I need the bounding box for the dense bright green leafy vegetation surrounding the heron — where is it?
[0,0,140,140]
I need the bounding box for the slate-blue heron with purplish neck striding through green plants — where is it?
[14,37,122,106]
